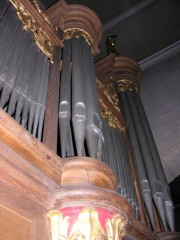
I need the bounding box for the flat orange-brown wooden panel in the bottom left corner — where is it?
[0,205,32,240]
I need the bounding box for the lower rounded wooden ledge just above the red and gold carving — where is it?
[53,186,133,219]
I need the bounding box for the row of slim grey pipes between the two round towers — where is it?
[102,119,139,219]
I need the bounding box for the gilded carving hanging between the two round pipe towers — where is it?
[97,80,126,132]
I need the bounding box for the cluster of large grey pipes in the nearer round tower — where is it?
[59,37,103,159]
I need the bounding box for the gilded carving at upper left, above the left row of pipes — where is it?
[10,0,55,62]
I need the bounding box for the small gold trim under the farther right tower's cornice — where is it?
[117,79,140,93]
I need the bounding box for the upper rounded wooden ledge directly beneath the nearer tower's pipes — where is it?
[61,157,117,190]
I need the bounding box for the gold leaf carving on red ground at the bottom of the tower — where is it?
[48,207,126,240]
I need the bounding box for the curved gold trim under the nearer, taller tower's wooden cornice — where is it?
[63,28,93,47]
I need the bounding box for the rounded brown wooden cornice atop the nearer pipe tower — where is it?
[46,0,102,55]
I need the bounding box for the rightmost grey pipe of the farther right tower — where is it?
[133,92,174,231]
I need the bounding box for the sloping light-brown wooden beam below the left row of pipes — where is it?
[0,109,63,184]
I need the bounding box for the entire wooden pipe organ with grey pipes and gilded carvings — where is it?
[0,0,180,240]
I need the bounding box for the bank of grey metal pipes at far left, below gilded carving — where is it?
[0,1,50,140]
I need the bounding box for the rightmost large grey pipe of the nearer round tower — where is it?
[82,37,102,158]
